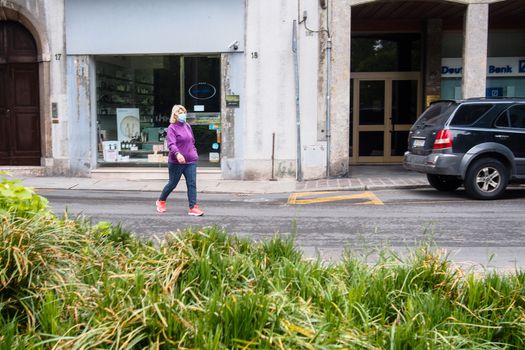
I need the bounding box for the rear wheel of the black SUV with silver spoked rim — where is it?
[464,158,509,199]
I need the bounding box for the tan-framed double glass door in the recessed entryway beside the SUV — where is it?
[351,72,421,163]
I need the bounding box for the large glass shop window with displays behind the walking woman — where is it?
[96,55,221,166]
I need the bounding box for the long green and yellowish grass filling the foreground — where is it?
[0,178,525,349]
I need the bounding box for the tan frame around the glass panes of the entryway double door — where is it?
[350,72,422,164]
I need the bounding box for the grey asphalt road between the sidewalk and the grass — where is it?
[40,189,525,270]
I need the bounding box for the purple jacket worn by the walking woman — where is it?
[166,122,199,164]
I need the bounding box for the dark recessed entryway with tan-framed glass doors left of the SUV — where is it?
[349,0,466,164]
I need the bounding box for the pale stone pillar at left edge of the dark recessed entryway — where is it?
[327,1,351,176]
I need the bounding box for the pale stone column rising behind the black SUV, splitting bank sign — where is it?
[461,4,489,98]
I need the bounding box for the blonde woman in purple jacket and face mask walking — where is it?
[156,105,204,216]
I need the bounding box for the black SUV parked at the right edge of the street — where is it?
[403,98,525,199]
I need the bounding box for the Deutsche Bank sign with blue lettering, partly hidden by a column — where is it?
[441,57,525,78]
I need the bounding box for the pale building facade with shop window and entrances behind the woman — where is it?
[0,0,525,180]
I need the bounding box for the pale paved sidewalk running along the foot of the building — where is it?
[4,165,428,194]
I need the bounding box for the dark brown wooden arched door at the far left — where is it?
[0,21,42,165]
